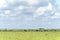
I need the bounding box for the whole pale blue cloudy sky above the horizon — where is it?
[0,0,60,29]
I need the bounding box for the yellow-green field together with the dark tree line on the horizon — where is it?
[0,29,60,40]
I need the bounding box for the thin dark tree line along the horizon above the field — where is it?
[0,28,60,32]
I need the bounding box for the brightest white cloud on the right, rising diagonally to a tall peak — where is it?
[34,3,53,16]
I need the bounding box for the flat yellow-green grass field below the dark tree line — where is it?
[0,31,60,40]
